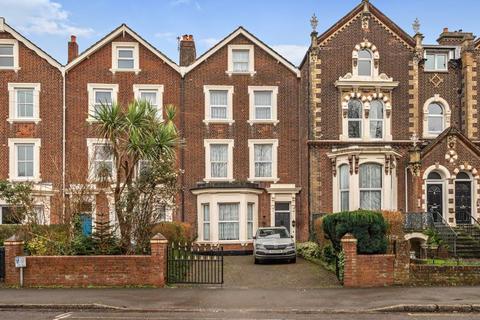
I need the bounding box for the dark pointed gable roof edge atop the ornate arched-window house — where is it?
[318,0,415,48]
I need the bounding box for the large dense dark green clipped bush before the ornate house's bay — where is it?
[322,210,387,254]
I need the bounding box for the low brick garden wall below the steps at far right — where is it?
[409,264,480,286]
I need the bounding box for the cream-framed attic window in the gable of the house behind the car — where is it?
[227,44,255,75]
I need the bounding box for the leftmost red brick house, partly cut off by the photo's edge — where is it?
[0,18,63,224]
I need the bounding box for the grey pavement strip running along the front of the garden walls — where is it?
[0,286,480,319]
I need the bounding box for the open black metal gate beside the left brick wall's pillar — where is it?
[167,243,223,284]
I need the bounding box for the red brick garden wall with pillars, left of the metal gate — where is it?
[5,235,167,287]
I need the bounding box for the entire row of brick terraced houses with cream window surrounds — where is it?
[0,0,480,250]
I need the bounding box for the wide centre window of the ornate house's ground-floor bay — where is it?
[359,163,382,210]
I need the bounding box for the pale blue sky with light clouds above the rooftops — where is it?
[0,0,480,65]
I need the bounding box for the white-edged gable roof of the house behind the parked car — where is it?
[184,27,300,77]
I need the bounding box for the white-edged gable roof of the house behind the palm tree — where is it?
[65,24,180,73]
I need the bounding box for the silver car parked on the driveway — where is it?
[253,227,297,263]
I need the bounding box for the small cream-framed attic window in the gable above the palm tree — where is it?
[111,42,140,73]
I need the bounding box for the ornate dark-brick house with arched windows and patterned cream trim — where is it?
[300,0,480,226]
